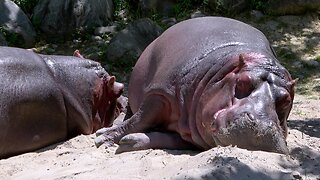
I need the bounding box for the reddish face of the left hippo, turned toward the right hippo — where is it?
[93,74,124,132]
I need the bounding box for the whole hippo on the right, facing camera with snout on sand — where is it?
[95,17,295,154]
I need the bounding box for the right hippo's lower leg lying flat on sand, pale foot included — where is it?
[116,132,197,153]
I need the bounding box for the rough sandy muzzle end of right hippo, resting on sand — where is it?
[212,112,288,154]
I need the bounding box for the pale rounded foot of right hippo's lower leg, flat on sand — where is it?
[116,133,151,154]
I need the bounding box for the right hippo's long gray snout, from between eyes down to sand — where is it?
[211,71,292,154]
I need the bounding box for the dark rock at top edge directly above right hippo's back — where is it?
[208,0,251,15]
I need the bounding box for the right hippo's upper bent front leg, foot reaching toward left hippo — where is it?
[95,95,169,147]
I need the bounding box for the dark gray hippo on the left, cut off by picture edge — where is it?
[0,47,123,159]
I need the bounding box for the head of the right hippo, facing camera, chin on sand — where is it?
[203,53,295,154]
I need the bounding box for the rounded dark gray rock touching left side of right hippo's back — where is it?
[104,18,162,65]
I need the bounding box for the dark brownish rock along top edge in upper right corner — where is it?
[266,0,320,15]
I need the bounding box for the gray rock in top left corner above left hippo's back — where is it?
[0,0,36,48]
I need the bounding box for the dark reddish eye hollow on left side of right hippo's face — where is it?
[235,75,254,99]
